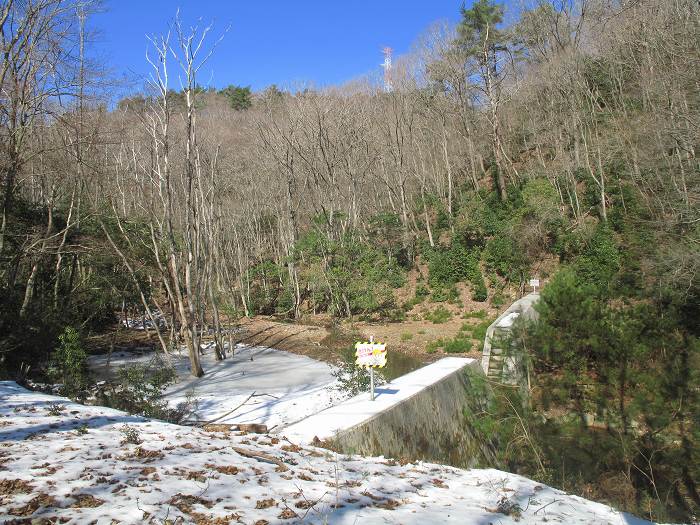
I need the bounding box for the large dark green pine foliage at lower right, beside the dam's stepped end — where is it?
[504,264,700,522]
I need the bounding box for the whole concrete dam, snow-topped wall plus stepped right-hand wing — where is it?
[276,293,539,468]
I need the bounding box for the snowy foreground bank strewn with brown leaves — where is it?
[0,382,647,525]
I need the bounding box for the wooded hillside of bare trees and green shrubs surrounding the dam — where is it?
[0,0,700,521]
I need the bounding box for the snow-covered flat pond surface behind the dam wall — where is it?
[90,345,347,429]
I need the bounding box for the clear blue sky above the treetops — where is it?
[89,0,470,94]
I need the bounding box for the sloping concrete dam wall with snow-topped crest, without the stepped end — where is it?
[279,357,492,466]
